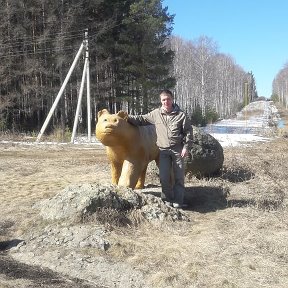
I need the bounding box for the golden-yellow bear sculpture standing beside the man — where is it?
[96,109,159,189]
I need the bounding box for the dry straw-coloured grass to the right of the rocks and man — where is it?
[108,139,288,288]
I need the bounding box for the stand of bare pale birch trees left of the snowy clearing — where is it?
[170,36,257,122]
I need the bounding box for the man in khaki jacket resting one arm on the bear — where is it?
[128,90,193,208]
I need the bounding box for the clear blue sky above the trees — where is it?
[163,0,288,98]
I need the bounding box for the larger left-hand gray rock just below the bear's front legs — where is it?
[34,184,141,222]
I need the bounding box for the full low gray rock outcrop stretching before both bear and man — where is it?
[34,184,189,223]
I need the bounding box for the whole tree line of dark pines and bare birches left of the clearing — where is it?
[0,0,257,136]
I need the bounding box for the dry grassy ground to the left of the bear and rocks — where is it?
[0,143,109,288]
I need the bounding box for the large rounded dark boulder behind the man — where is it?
[186,126,224,177]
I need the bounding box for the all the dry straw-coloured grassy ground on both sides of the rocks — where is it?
[0,111,288,288]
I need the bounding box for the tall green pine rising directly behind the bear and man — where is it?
[119,0,175,113]
